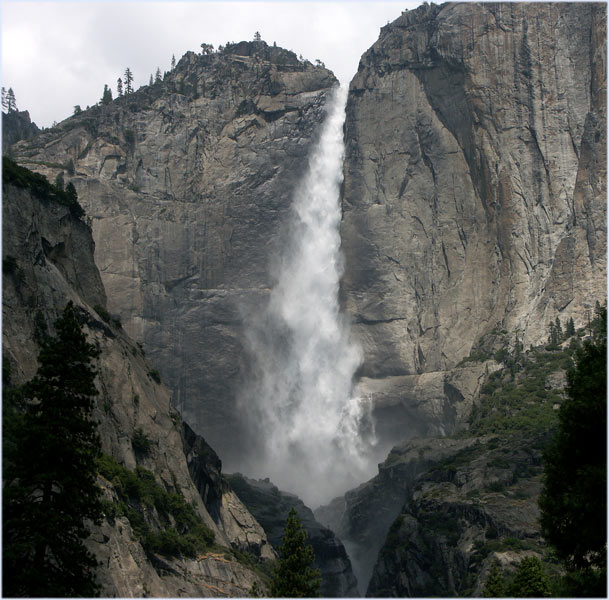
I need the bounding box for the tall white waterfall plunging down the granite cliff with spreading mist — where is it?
[239,87,376,507]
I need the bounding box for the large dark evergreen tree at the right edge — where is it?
[539,308,607,596]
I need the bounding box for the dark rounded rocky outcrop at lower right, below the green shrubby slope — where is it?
[367,436,551,598]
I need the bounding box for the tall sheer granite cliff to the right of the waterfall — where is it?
[341,3,606,441]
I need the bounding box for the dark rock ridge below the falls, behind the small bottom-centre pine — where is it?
[229,473,360,598]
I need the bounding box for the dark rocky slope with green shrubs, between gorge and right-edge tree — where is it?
[315,336,585,597]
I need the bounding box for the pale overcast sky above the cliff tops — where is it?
[2,0,421,127]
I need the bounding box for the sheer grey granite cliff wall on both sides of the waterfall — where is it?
[12,3,606,474]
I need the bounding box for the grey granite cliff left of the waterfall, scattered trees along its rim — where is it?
[13,42,337,462]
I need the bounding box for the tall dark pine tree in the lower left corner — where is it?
[2,302,102,597]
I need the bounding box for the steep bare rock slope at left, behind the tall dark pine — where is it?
[2,180,274,597]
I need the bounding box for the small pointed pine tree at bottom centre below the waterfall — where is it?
[271,508,321,598]
